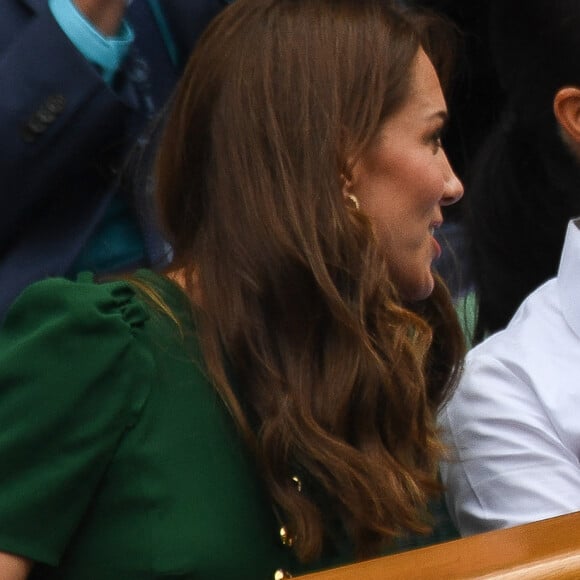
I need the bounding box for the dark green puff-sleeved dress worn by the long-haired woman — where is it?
[0,271,460,580]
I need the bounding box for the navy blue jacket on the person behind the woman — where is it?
[0,0,231,320]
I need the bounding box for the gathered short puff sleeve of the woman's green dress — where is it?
[0,276,153,565]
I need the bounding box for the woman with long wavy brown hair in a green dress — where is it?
[0,0,463,580]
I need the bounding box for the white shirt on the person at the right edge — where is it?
[440,219,580,535]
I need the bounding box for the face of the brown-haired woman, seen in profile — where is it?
[346,50,463,300]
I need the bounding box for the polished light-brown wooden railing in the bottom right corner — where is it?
[300,512,580,580]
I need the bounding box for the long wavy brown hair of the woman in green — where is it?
[156,0,463,560]
